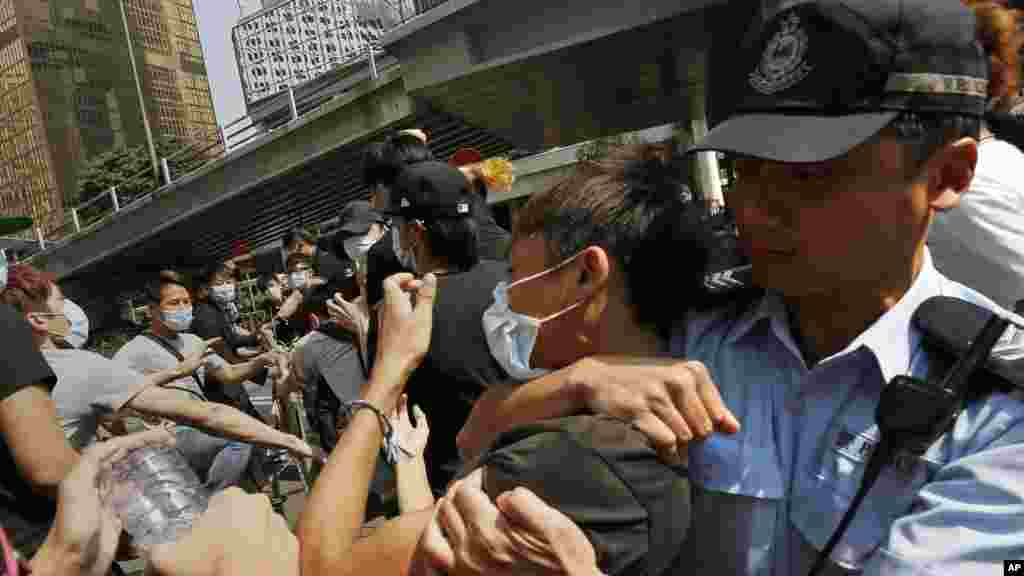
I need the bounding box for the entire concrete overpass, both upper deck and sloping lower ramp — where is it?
[28,0,771,325]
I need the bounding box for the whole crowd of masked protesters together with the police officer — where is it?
[0,0,1024,576]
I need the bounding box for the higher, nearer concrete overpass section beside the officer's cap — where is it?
[383,0,761,150]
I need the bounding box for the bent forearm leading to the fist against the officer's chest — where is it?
[456,365,584,460]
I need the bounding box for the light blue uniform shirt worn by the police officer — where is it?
[672,251,1024,576]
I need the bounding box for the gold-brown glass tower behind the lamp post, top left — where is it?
[0,0,220,236]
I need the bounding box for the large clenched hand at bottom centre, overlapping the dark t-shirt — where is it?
[410,469,600,576]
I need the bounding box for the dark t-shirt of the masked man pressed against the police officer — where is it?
[477,416,690,576]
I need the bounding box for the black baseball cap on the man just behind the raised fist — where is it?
[385,161,472,220]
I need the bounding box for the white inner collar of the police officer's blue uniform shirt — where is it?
[728,248,943,382]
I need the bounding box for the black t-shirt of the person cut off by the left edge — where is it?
[0,304,58,556]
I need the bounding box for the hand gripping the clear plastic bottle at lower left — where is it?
[32,428,174,576]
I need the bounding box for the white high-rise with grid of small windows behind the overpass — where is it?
[231,0,416,106]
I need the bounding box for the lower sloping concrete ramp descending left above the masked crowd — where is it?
[31,66,512,324]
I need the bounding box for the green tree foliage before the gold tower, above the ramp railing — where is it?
[74,136,209,223]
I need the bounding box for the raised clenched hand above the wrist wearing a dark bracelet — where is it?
[375,274,437,384]
